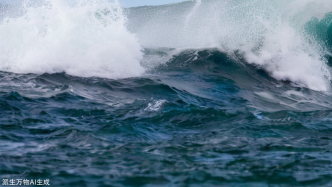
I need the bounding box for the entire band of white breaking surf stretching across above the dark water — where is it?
[0,0,332,91]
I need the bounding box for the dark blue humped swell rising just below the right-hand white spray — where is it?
[150,49,331,111]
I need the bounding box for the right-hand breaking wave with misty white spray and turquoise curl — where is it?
[128,0,332,91]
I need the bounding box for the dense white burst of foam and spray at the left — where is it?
[0,0,144,78]
